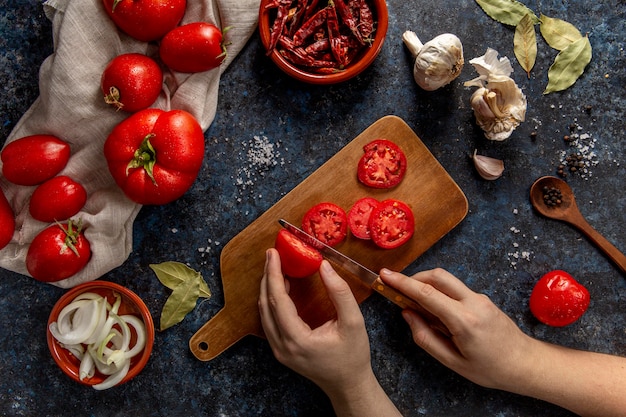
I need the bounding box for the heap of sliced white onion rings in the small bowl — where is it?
[49,292,146,390]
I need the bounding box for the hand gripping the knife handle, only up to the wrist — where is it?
[381,269,535,389]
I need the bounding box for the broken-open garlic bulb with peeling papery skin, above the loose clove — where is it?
[464,48,526,141]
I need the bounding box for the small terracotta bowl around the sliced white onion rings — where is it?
[46,280,154,385]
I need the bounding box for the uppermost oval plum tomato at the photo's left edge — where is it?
[0,135,71,185]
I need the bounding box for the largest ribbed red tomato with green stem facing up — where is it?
[104,109,204,205]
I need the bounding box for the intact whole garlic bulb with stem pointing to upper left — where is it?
[402,30,463,91]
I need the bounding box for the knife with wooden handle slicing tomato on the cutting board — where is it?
[278,219,450,336]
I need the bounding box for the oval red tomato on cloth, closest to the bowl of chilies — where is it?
[159,22,226,72]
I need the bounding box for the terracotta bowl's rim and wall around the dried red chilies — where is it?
[259,0,389,84]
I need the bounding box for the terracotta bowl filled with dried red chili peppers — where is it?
[259,0,389,84]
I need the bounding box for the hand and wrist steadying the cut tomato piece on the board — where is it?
[259,249,400,417]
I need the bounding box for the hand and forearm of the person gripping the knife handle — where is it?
[380,269,626,417]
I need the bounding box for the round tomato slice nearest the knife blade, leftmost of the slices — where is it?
[302,203,348,246]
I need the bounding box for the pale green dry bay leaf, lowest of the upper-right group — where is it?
[543,36,592,94]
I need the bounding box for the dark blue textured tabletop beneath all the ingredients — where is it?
[0,0,626,417]
